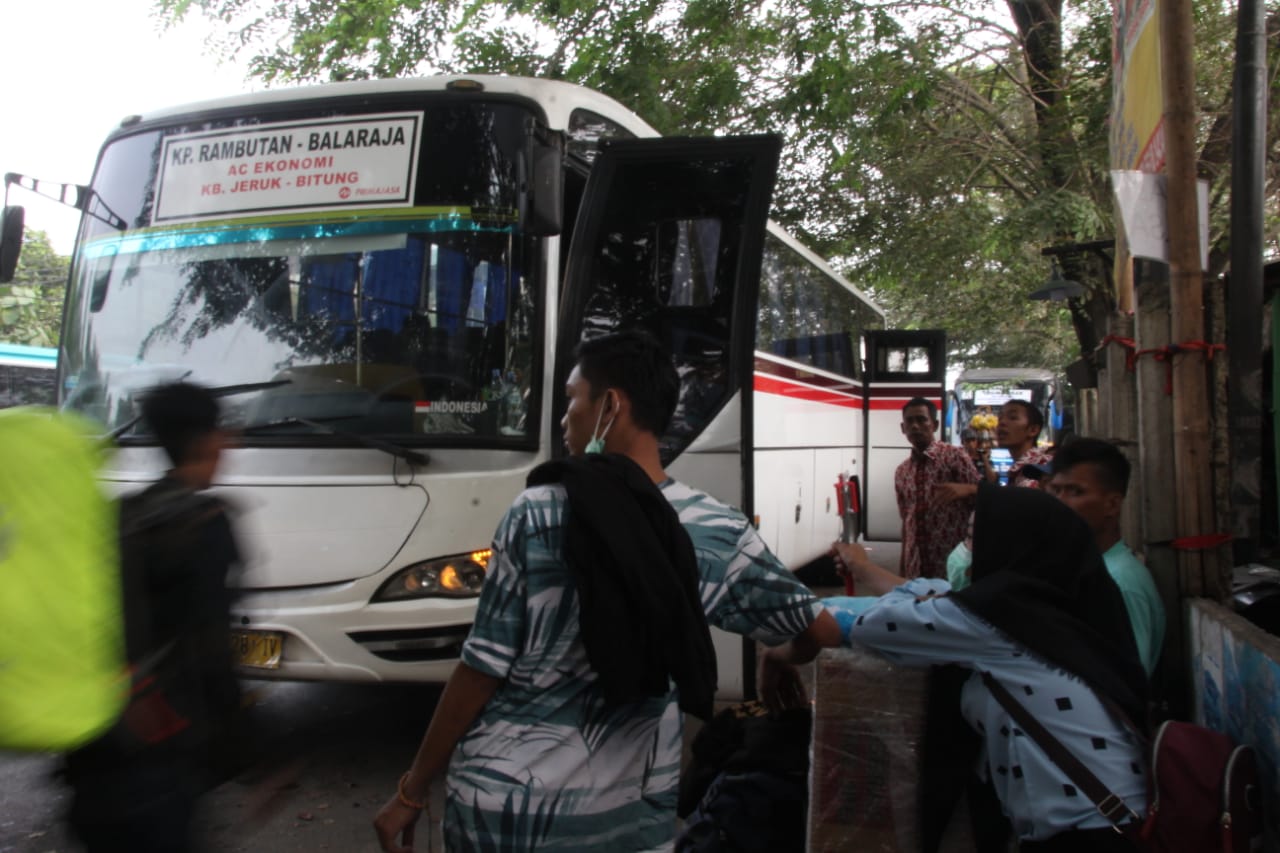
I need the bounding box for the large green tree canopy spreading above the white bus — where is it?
[157,0,1280,368]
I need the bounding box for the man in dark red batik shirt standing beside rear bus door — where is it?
[893,397,979,580]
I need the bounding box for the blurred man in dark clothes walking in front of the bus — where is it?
[67,383,239,853]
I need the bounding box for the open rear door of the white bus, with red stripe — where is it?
[863,329,947,540]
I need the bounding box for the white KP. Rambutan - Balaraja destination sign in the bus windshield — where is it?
[151,113,422,224]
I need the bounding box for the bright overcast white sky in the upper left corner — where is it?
[0,0,253,254]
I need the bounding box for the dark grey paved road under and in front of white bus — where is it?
[0,543,899,853]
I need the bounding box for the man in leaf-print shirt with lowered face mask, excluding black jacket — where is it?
[375,333,840,853]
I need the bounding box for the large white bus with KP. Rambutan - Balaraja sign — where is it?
[5,77,942,695]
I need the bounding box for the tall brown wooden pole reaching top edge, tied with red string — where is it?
[1160,0,1226,599]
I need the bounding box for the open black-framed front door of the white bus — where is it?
[552,136,781,695]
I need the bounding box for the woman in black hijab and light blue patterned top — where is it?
[849,485,1147,853]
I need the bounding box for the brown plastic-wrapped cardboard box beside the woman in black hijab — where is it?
[808,648,973,853]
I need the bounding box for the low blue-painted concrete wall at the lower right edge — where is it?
[1189,598,1280,853]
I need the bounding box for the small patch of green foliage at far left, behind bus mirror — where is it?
[0,228,70,347]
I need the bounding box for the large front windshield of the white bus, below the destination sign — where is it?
[61,97,540,446]
